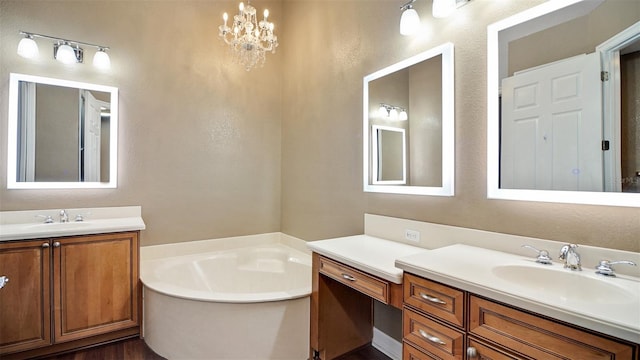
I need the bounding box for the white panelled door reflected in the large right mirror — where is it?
[500,53,603,191]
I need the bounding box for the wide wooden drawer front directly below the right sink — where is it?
[469,296,634,360]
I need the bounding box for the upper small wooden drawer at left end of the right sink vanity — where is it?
[404,273,465,328]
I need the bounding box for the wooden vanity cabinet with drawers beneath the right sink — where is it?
[403,273,639,360]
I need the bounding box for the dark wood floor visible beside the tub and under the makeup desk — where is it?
[45,338,391,360]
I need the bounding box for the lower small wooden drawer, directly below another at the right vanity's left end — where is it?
[402,307,465,359]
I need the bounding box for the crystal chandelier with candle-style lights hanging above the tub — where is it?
[218,3,278,71]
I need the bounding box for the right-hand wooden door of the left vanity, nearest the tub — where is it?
[53,232,139,343]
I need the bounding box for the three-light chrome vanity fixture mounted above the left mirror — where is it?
[18,31,111,69]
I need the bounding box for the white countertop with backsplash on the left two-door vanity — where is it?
[0,206,146,241]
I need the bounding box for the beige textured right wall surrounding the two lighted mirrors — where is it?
[282,0,640,251]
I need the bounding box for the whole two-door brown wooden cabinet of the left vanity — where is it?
[0,231,141,359]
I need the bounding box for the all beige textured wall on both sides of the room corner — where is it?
[0,0,640,251]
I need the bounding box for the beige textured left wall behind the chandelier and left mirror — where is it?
[0,0,283,245]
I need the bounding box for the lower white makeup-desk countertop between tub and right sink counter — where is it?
[307,235,429,284]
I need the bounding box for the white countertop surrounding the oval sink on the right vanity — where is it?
[395,244,640,343]
